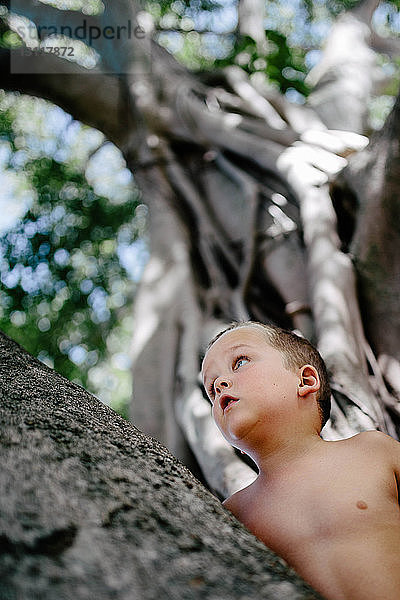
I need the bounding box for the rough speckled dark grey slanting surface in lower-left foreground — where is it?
[0,335,318,600]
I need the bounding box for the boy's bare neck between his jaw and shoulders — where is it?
[252,432,326,483]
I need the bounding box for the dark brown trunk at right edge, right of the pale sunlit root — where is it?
[344,94,400,422]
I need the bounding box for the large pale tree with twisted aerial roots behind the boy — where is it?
[2,0,400,548]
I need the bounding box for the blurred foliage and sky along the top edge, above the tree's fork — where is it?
[146,0,399,101]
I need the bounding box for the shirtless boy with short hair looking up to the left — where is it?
[202,322,400,600]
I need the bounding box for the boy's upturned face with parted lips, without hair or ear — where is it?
[202,326,299,450]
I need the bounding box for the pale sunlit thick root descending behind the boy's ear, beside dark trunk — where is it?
[278,129,393,433]
